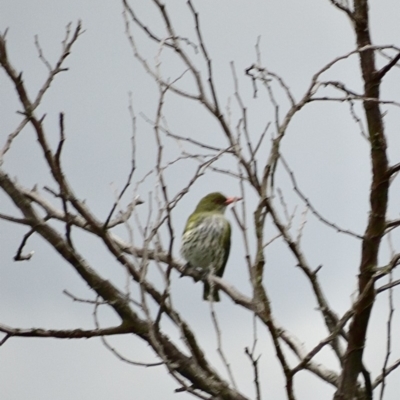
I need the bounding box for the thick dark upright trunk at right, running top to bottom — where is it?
[334,0,389,400]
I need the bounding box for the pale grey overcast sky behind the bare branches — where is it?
[0,0,400,400]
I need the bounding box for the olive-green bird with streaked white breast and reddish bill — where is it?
[181,192,240,302]
